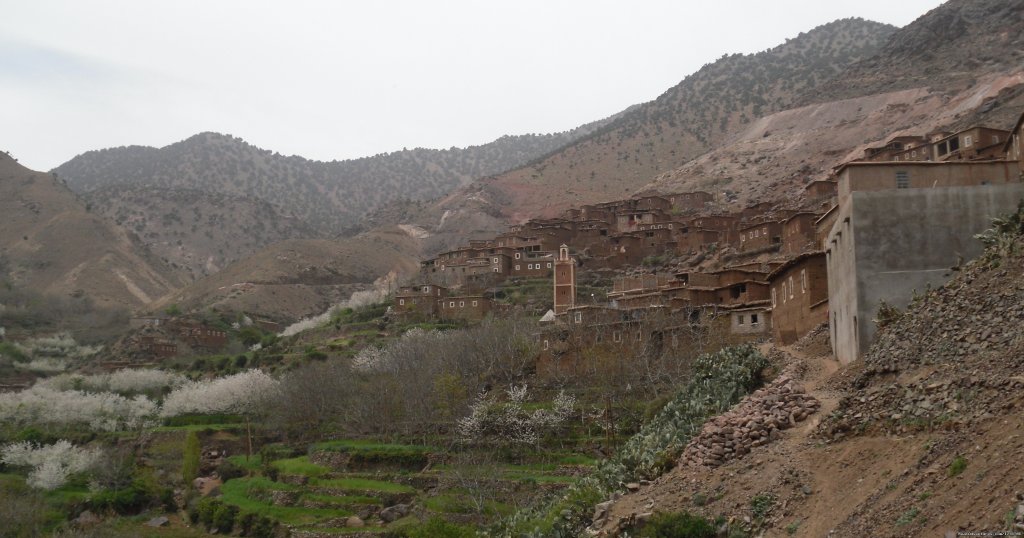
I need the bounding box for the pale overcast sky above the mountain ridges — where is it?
[0,0,941,170]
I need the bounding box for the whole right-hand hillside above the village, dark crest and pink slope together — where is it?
[641,0,1024,208]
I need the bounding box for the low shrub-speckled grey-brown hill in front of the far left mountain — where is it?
[83,185,317,280]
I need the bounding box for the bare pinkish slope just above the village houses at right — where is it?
[640,71,1024,205]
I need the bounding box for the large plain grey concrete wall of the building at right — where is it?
[825,183,1024,363]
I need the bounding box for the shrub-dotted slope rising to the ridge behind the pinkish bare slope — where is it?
[432,18,895,226]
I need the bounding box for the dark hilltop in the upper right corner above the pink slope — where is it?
[801,0,1024,104]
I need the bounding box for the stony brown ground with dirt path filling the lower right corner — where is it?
[591,241,1024,538]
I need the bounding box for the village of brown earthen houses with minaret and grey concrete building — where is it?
[392,110,1024,371]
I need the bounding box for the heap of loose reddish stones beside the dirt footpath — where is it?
[680,373,821,467]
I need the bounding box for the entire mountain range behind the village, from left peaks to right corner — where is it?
[5,0,1024,318]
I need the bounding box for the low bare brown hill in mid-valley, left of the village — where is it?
[154,229,420,322]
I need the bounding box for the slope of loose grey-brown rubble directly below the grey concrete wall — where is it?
[818,244,1024,440]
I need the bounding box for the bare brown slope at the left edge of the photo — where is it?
[0,154,183,309]
